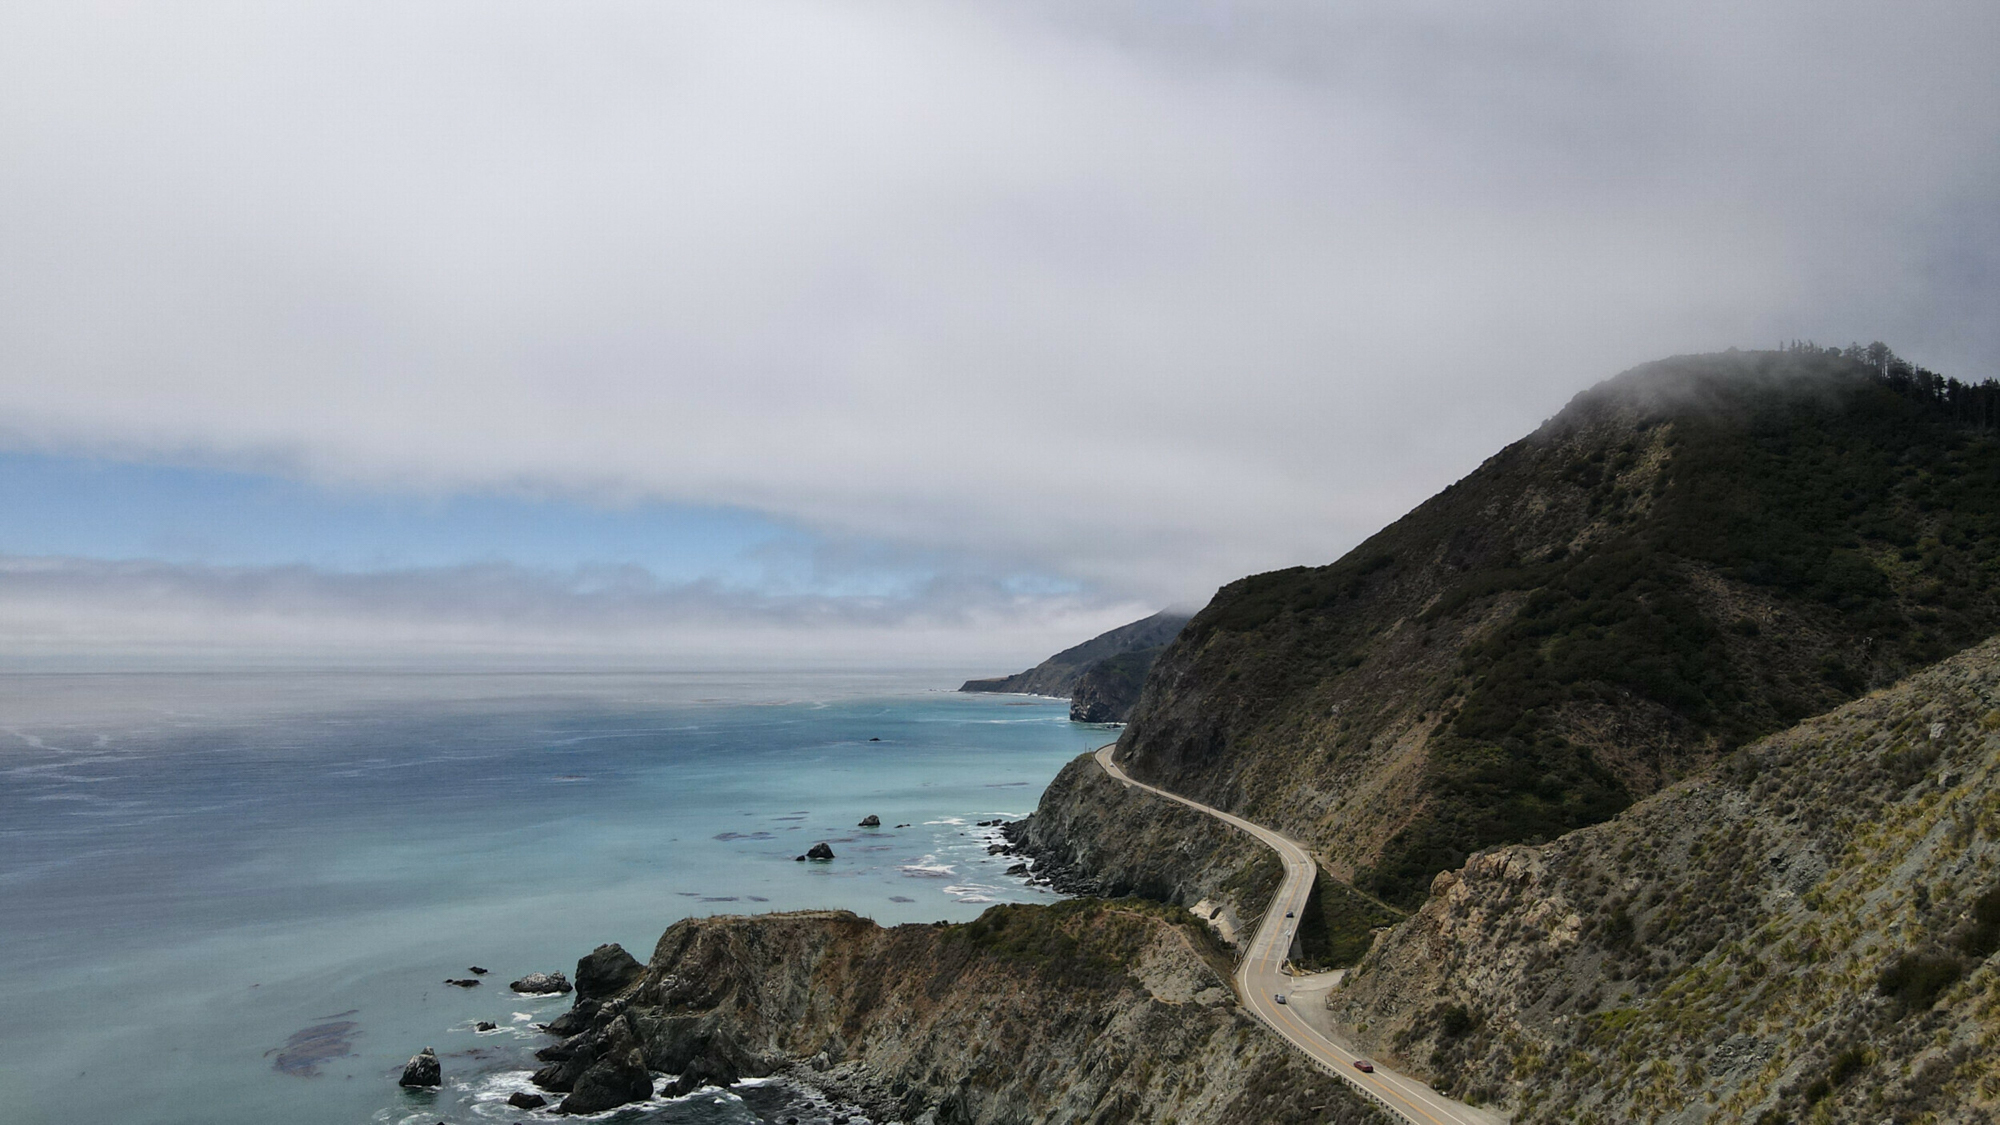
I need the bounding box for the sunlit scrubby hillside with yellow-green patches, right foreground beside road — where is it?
[1332,643,2000,1125]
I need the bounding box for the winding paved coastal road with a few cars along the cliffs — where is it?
[1098,743,1506,1125]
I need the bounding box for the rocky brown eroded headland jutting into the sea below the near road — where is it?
[554,899,1382,1125]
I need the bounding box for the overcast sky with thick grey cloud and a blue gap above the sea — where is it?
[0,0,2000,671]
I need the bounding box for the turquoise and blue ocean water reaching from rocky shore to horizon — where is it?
[0,673,1104,1125]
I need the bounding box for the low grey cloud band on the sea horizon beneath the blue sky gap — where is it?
[0,556,1148,671]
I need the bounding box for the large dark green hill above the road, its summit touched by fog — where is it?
[1104,348,2000,905]
